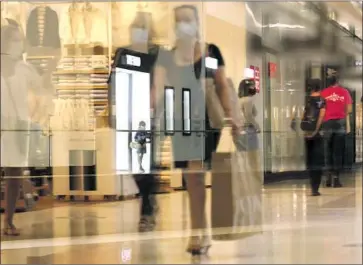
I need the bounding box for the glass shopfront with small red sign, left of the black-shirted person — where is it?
[264,53,305,173]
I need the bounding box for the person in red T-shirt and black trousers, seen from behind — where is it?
[321,76,352,187]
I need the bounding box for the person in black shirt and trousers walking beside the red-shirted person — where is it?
[302,79,325,196]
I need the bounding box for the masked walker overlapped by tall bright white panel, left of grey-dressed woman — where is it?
[109,10,160,231]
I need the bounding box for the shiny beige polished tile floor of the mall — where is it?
[1,172,362,264]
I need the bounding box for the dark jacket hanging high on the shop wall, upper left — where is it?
[26,6,61,48]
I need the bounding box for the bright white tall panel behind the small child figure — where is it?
[114,68,151,174]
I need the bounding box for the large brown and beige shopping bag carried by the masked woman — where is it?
[212,126,262,240]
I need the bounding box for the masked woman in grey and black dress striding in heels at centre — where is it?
[153,5,240,254]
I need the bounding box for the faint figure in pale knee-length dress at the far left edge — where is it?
[1,24,44,233]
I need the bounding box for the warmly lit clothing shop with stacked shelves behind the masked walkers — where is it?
[1,1,250,200]
